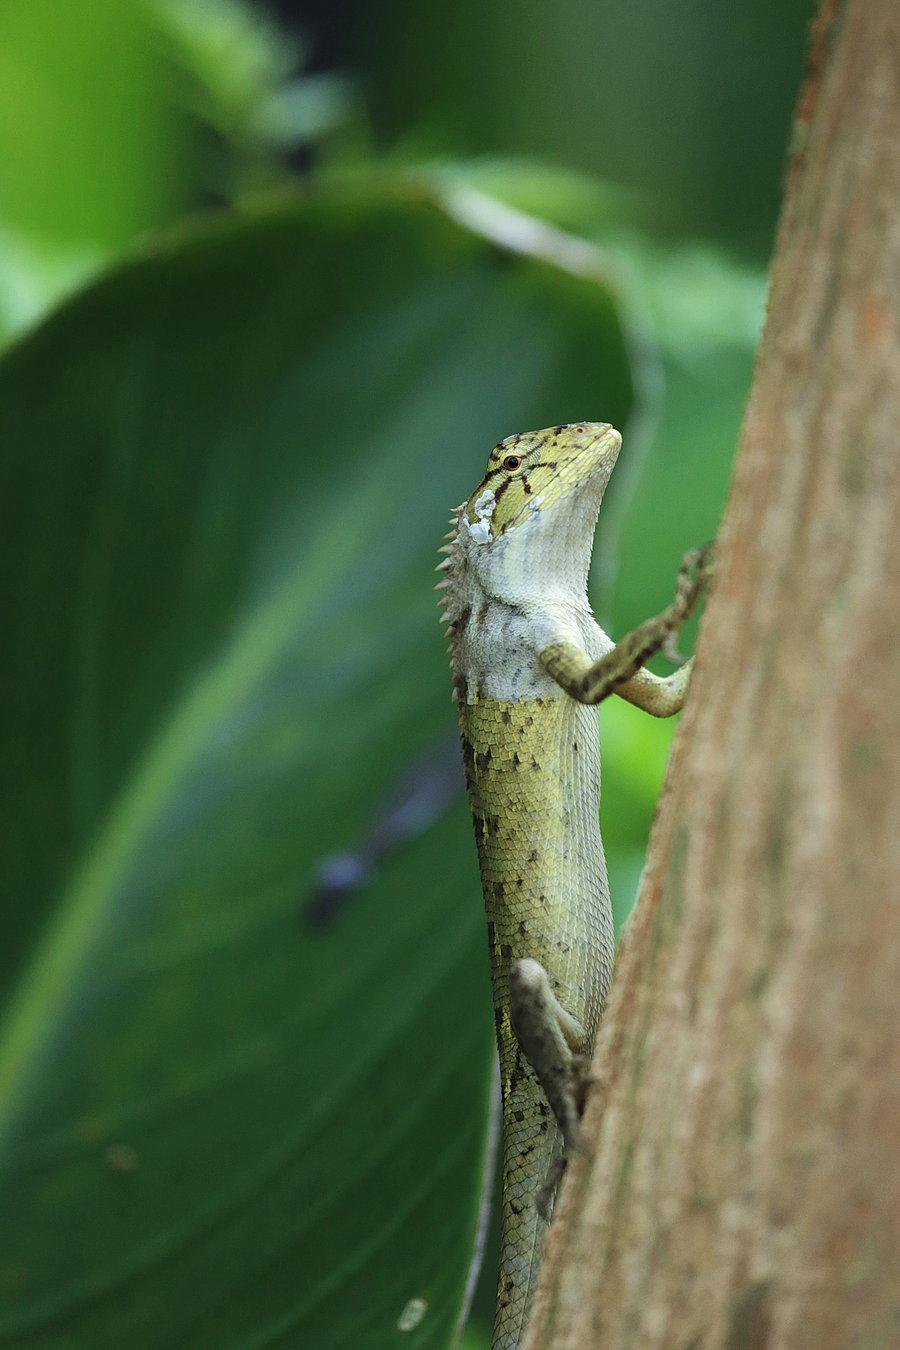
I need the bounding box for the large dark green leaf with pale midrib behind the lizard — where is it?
[0,189,630,1350]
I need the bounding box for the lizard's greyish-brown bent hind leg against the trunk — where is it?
[509,957,584,1166]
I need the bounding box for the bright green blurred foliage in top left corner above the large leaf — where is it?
[0,0,354,339]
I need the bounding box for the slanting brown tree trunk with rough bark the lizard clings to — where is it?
[526,0,900,1350]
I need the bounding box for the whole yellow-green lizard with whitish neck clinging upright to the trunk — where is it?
[439,421,706,1350]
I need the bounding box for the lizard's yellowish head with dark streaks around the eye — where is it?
[460,423,622,545]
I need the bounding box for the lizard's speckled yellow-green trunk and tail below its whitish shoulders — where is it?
[460,690,614,1345]
